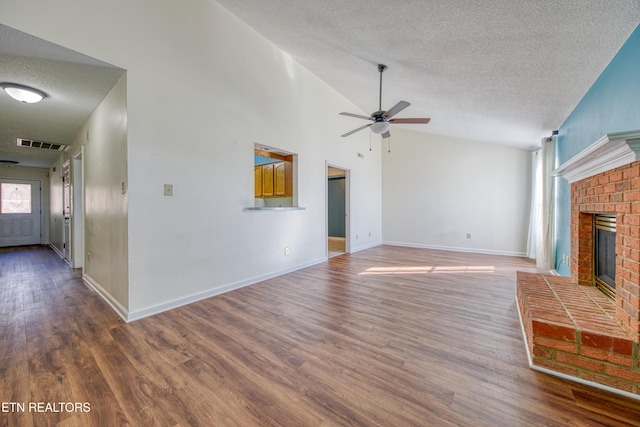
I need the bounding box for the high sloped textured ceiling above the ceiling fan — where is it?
[219,0,640,148]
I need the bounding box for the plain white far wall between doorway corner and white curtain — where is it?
[382,126,531,255]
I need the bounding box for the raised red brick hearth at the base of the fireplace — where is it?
[517,272,640,394]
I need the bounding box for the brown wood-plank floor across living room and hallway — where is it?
[0,246,640,427]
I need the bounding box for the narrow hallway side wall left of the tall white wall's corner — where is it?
[79,77,129,310]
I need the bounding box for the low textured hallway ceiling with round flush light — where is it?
[0,24,124,167]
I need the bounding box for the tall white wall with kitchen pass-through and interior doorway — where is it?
[0,0,382,319]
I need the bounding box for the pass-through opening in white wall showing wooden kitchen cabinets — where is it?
[253,144,297,208]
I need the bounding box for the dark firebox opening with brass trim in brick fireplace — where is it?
[593,215,616,299]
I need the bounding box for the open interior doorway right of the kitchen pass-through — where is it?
[327,164,349,258]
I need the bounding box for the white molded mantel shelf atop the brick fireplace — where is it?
[551,130,640,184]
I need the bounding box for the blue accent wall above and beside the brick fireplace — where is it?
[556,26,640,276]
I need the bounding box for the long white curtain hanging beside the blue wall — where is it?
[527,137,556,270]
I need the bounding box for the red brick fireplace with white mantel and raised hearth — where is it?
[517,131,640,398]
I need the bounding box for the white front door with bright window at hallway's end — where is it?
[0,179,41,247]
